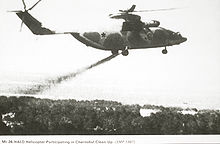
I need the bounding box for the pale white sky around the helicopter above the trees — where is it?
[0,0,220,109]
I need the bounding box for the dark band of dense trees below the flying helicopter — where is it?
[0,96,220,135]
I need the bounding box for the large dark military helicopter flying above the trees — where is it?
[13,0,187,56]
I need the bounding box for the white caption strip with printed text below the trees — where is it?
[0,135,220,144]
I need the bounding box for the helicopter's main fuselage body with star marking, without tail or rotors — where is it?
[71,27,187,52]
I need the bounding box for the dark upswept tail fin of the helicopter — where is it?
[16,10,55,35]
